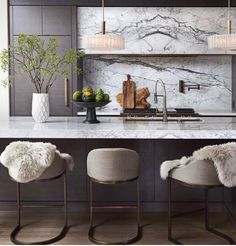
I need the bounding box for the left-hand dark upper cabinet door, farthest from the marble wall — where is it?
[12,6,42,35]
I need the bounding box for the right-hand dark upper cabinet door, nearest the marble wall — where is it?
[43,6,72,35]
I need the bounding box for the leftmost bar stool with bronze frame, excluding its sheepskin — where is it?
[10,153,68,245]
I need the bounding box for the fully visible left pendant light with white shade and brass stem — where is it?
[87,0,125,51]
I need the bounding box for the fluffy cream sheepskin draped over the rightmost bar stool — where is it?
[160,142,236,187]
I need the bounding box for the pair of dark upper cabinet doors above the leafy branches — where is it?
[12,6,72,36]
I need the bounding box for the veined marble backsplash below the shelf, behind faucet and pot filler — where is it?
[83,55,232,112]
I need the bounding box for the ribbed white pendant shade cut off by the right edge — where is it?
[208,33,236,50]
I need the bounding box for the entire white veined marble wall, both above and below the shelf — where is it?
[78,7,232,112]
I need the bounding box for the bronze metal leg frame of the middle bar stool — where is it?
[88,179,142,245]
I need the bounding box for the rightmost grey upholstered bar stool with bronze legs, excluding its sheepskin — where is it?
[166,160,235,244]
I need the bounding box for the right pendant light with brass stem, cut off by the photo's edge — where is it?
[208,0,236,50]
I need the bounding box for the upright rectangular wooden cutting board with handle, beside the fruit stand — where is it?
[123,74,135,109]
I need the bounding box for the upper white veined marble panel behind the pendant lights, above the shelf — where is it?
[78,7,236,54]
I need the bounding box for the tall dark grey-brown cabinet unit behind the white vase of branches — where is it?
[10,6,78,116]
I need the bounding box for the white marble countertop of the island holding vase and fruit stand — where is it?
[0,117,236,139]
